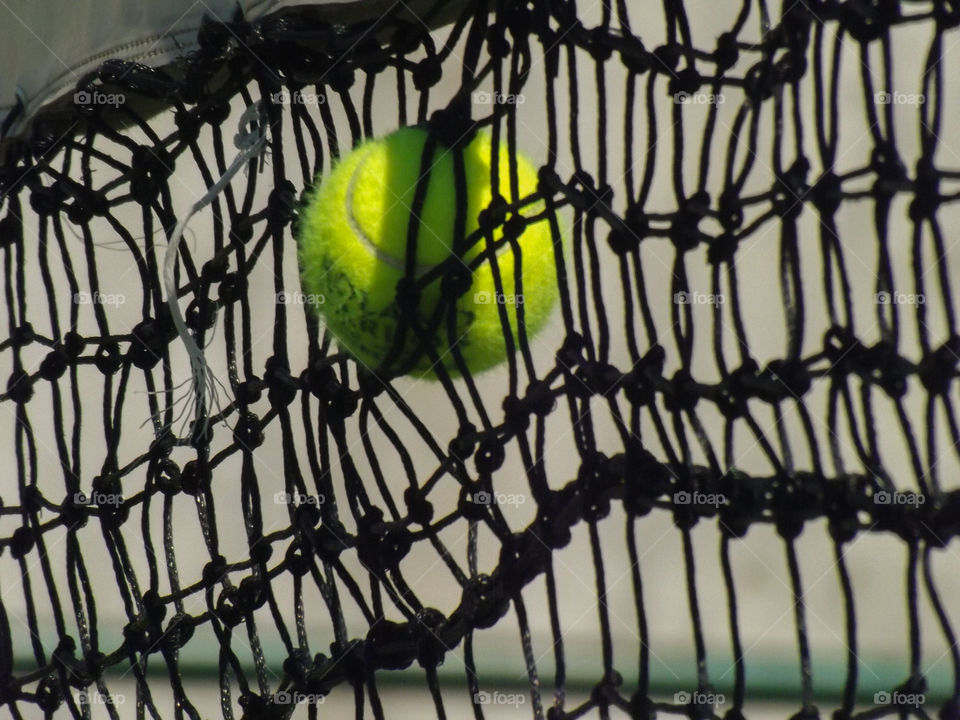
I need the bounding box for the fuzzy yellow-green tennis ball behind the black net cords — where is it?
[297,127,557,376]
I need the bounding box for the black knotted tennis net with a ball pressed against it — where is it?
[0,0,960,720]
